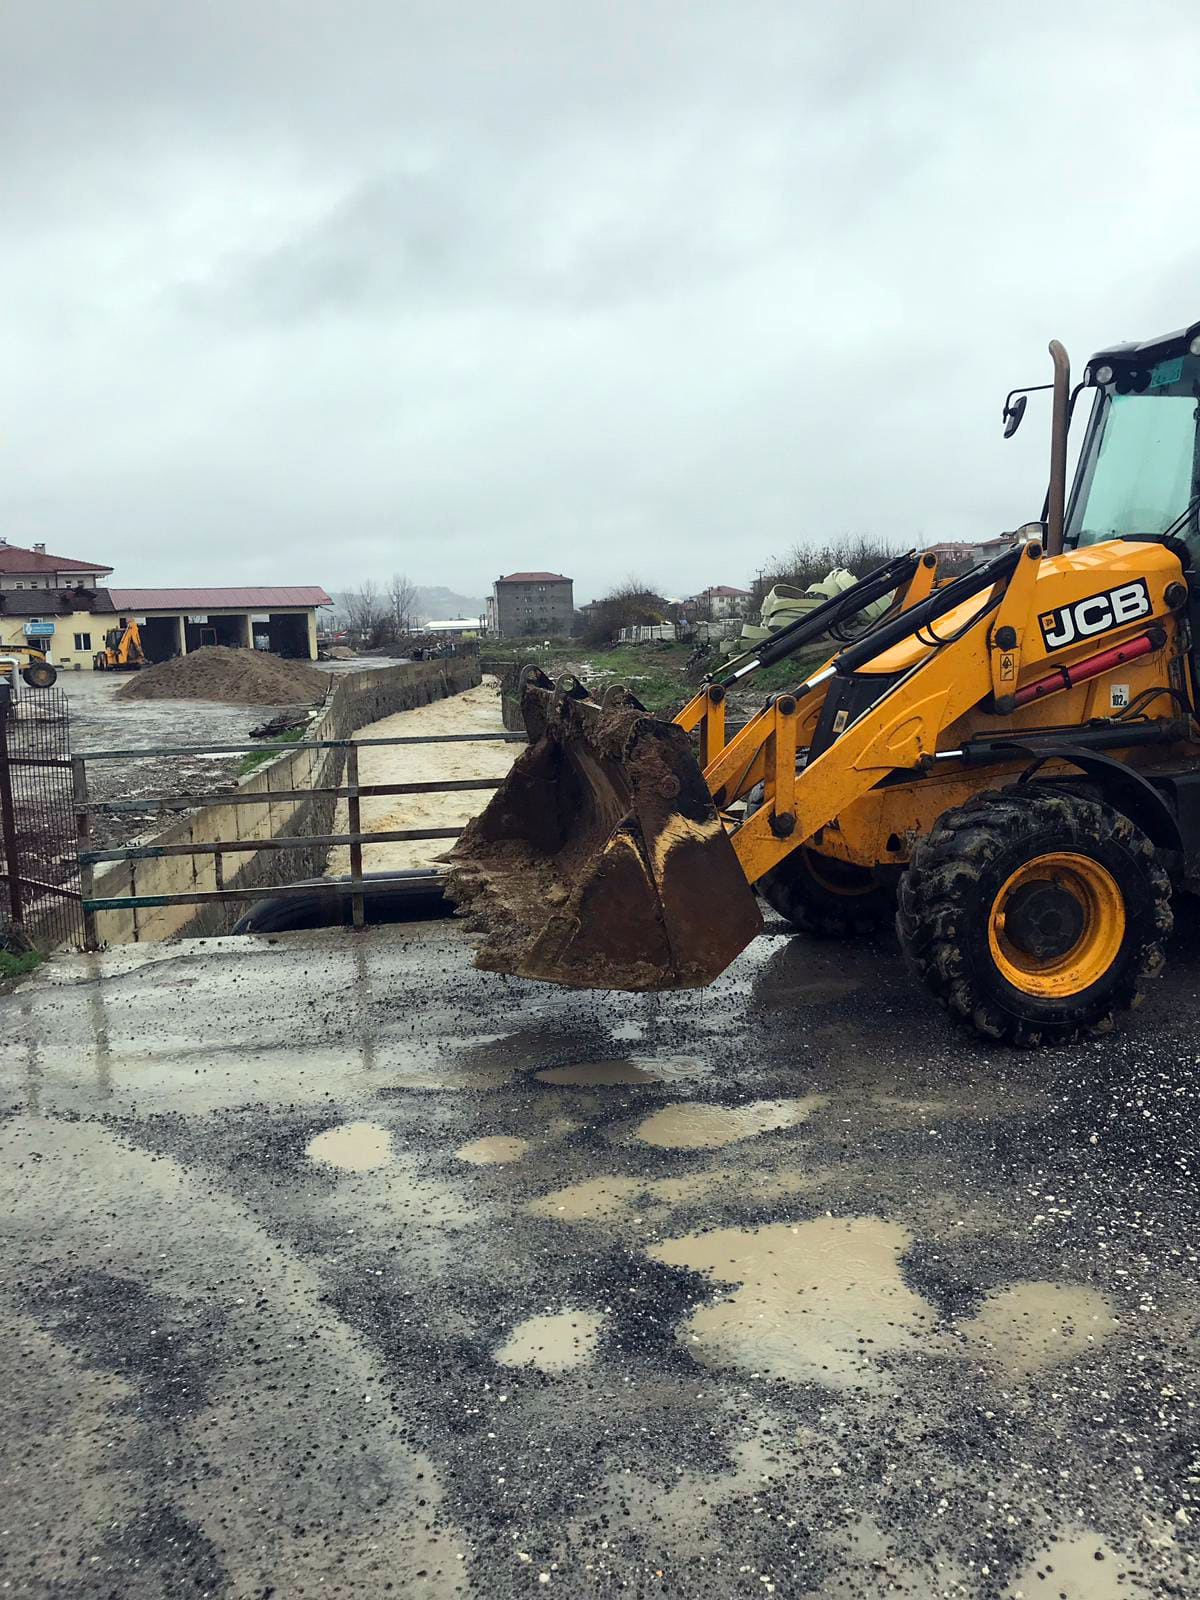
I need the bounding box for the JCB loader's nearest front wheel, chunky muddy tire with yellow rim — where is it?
[896,786,1171,1046]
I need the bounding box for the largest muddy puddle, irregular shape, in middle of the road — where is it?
[650,1216,934,1387]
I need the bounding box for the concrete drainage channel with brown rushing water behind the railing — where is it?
[75,656,522,949]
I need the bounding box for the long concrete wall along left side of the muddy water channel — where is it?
[96,658,480,944]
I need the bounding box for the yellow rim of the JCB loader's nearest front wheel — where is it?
[987,851,1125,1000]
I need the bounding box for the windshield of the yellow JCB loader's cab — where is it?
[1067,355,1200,558]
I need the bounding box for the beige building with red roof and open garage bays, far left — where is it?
[0,541,333,670]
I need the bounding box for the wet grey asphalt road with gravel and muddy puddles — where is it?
[0,912,1200,1600]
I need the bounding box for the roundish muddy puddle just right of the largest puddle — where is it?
[958,1283,1117,1378]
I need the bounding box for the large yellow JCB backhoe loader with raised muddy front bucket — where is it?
[448,323,1200,1045]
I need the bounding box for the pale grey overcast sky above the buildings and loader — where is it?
[0,0,1200,600]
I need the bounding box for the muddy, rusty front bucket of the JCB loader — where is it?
[446,686,762,990]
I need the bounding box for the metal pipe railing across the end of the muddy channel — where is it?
[72,733,526,950]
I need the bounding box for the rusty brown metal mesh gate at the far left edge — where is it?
[0,678,83,950]
